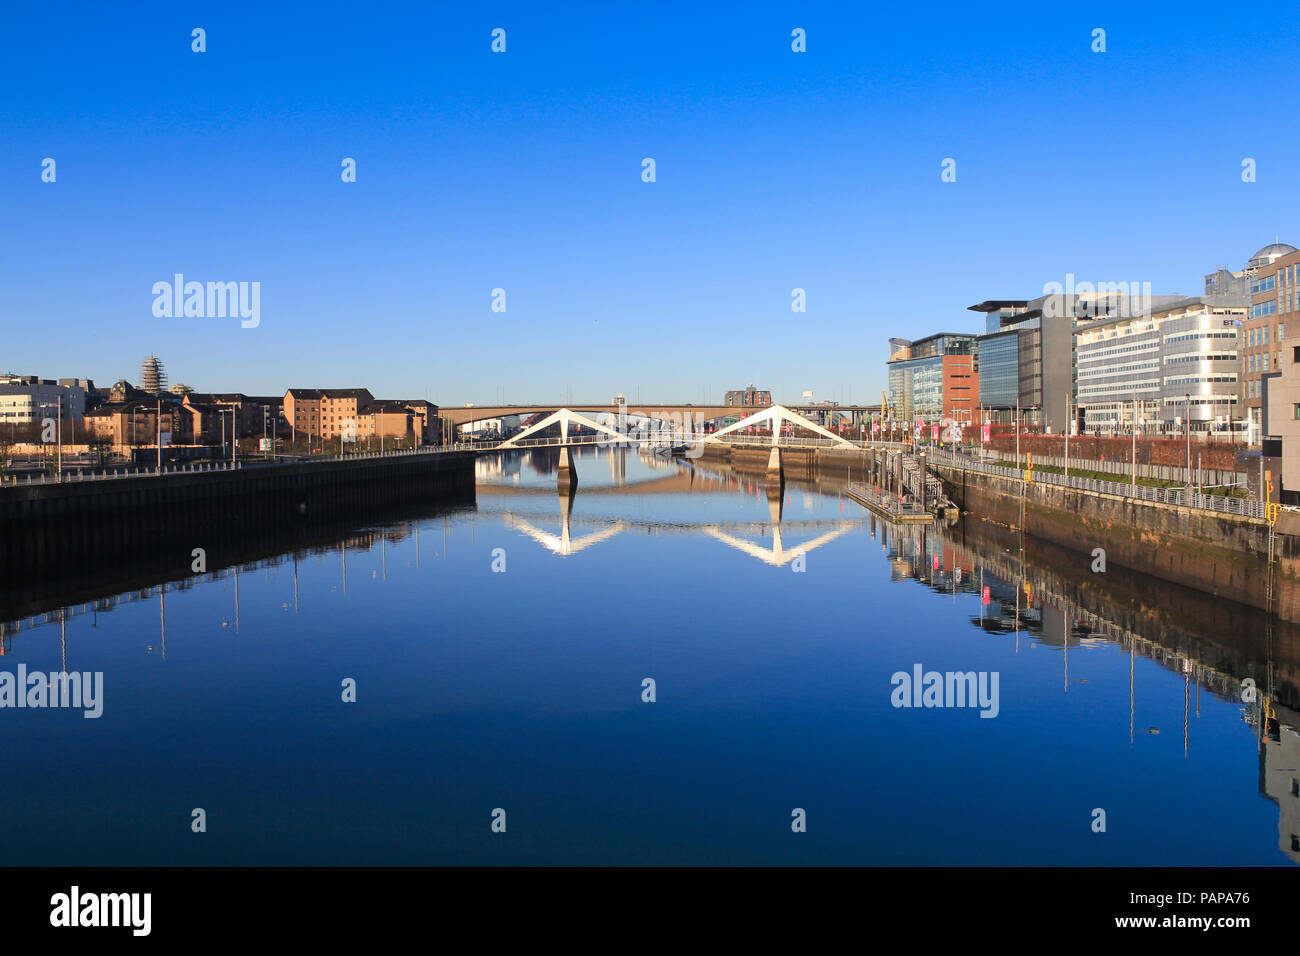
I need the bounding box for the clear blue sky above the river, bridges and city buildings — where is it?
[0,3,1300,405]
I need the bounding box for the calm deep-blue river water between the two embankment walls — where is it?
[0,450,1300,865]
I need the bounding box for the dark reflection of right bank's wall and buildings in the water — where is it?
[872,509,1300,864]
